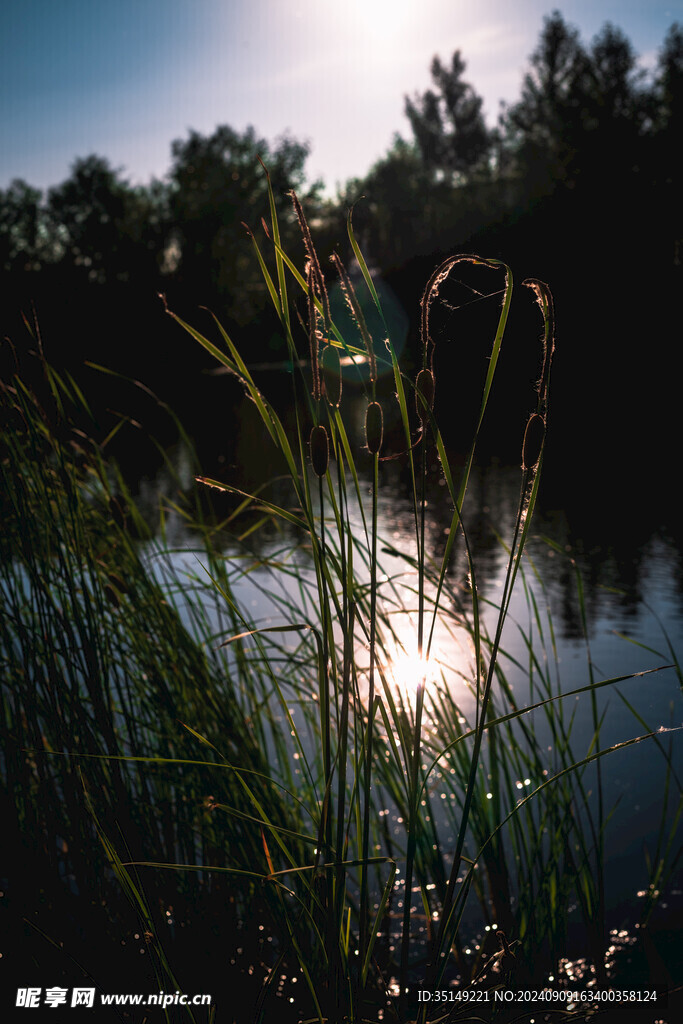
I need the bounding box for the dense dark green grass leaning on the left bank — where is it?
[0,342,313,1019]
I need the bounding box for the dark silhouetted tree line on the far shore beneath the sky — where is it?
[0,11,683,471]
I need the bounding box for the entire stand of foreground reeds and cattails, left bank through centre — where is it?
[0,169,682,1024]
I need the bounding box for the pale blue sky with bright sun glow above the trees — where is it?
[0,0,683,195]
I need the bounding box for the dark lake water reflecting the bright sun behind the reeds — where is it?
[137,370,683,999]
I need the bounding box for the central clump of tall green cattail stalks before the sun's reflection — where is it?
[153,174,680,1021]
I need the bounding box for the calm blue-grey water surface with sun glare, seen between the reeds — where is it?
[125,366,683,999]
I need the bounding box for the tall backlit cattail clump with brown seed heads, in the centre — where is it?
[82,161,675,1024]
